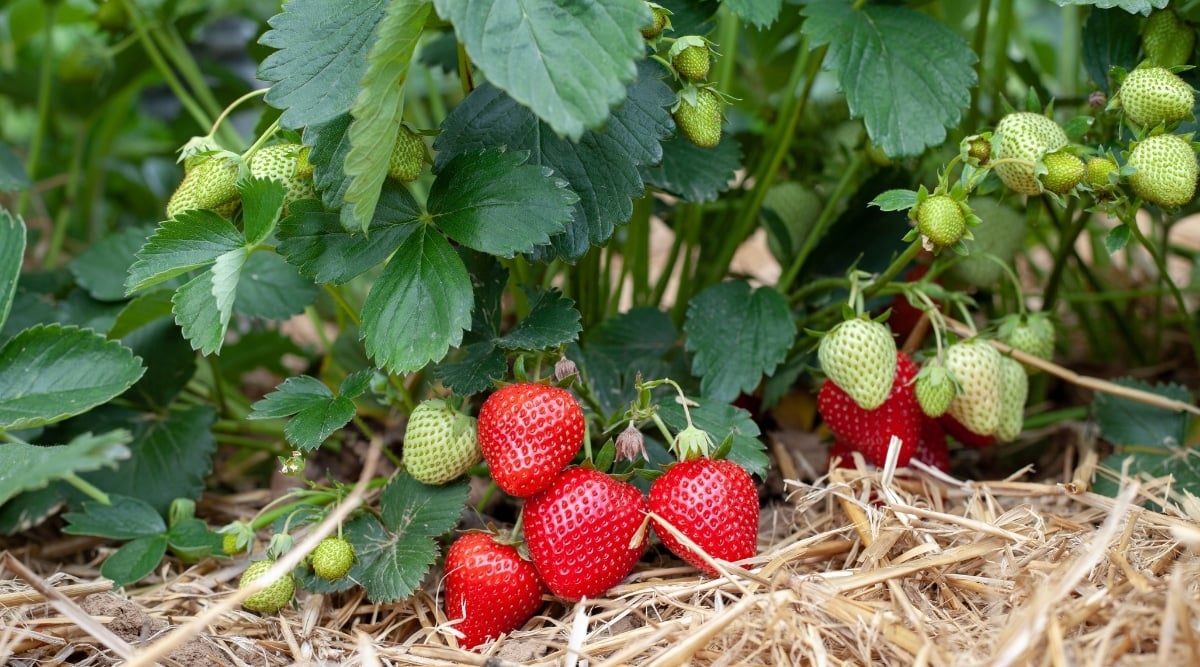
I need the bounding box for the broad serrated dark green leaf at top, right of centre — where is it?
[802,0,978,157]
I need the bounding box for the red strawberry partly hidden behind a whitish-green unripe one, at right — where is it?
[817,351,922,465]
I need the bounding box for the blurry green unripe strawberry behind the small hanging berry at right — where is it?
[947,197,1025,287]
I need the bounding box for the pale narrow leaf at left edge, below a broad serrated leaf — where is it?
[0,431,131,505]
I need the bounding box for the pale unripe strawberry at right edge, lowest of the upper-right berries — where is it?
[1128,134,1200,208]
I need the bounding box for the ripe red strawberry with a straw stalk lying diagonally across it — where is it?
[650,458,758,576]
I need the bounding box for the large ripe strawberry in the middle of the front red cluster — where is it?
[524,468,647,600]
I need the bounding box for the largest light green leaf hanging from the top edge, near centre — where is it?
[434,0,650,140]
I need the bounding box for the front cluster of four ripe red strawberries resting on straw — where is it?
[445,383,758,648]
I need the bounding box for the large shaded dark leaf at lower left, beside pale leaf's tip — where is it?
[76,405,217,513]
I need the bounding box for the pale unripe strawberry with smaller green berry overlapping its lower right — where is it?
[991,112,1067,196]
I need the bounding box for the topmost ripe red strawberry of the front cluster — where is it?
[478,383,584,498]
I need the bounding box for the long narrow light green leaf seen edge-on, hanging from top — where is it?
[344,0,432,232]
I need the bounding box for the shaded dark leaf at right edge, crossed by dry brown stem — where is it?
[1092,378,1192,449]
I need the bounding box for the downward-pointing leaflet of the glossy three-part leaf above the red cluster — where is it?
[362,224,473,373]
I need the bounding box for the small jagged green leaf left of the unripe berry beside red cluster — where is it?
[246,375,355,451]
